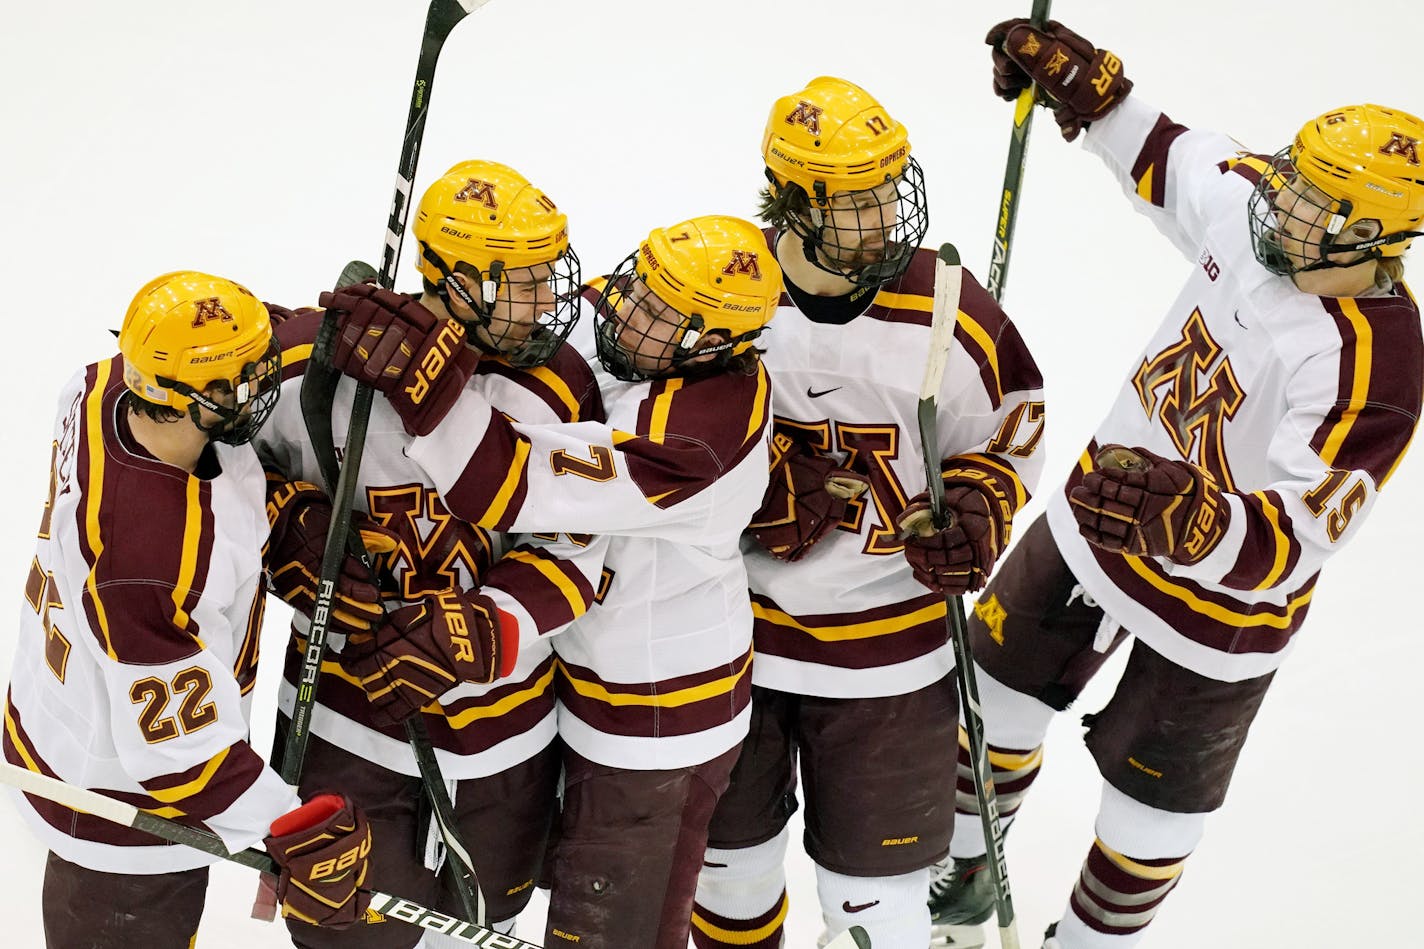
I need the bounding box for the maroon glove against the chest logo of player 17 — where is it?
[748,432,870,561]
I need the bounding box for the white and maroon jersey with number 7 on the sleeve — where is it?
[409,295,770,769]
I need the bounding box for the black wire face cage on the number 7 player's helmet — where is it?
[594,251,762,382]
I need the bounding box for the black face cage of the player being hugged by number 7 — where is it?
[420,241,582,369]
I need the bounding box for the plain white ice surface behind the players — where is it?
[0,0,1424,949]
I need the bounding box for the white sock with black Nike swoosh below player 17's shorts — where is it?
[816,865,930,946]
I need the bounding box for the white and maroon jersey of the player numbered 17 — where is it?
[745,232,1044,698]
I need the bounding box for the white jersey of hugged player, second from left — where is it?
[258,311,607,779]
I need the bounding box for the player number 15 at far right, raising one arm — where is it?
[936,20,1424,949]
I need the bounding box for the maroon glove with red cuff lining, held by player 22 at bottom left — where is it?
[262,794,370,929]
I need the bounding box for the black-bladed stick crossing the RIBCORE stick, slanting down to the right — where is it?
[302,261,486,923]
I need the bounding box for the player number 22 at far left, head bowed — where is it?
[4,271,370,949]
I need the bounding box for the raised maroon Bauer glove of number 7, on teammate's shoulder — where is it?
[319,284,480,435]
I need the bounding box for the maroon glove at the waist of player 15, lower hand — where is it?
[1068,445,1230,564]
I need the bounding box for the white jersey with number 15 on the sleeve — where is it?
[1048,94,1424,681]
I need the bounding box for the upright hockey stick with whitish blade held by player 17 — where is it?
[918,244,1018,949]
